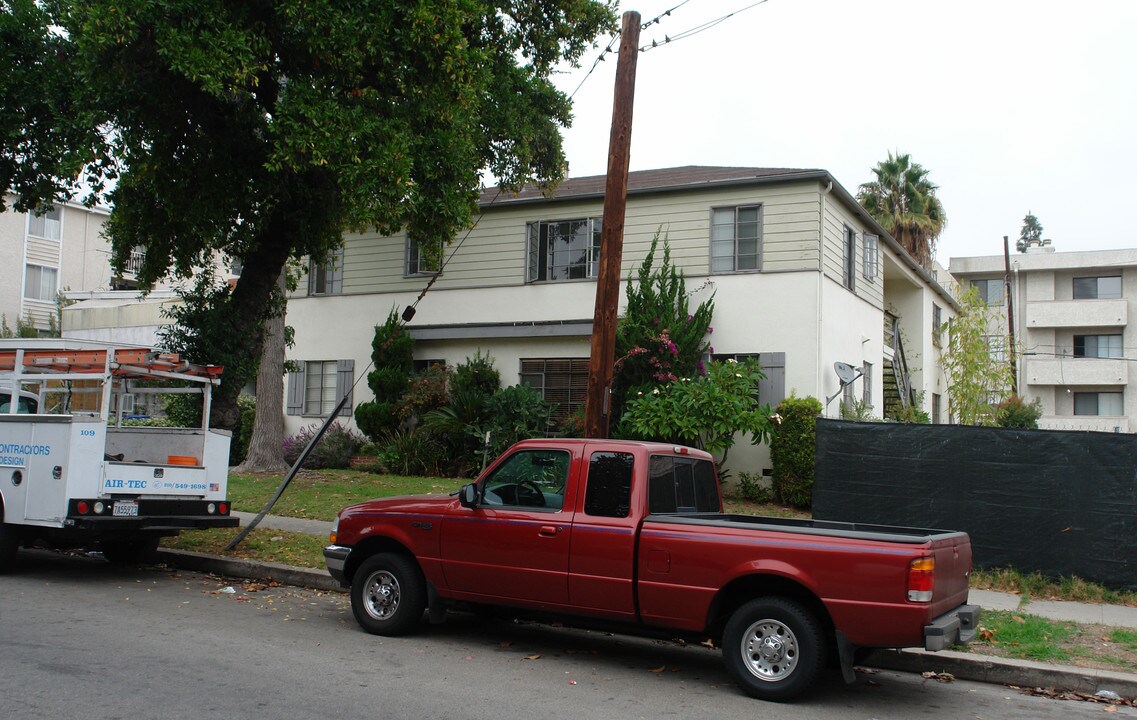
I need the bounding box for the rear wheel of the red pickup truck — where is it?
[722,597,825,702]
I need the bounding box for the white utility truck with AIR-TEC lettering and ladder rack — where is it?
[0,338,238,572]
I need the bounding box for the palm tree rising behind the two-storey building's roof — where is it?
[856,151,947,267]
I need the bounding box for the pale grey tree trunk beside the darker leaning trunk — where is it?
[236,270,288,473]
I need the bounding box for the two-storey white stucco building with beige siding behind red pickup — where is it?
[285,167,957,472]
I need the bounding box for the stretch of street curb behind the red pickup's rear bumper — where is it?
[862,649,1137,698]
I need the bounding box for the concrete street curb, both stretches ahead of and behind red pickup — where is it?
[158,548,1137,698]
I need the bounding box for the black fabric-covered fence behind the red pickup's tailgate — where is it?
[813,419,1137,588]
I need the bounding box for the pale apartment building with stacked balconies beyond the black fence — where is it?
[951,241,1137,432]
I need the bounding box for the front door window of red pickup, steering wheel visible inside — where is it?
[482,450,570,510]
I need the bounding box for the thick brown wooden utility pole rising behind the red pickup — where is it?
[584,11,640,438]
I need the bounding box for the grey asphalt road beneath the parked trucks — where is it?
[0,552,1137,720]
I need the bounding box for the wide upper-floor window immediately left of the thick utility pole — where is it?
[525,217,600,282]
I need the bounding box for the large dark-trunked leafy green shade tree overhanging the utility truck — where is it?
[0,0,614,427]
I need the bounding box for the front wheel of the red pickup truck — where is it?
[351,553,426,636]
